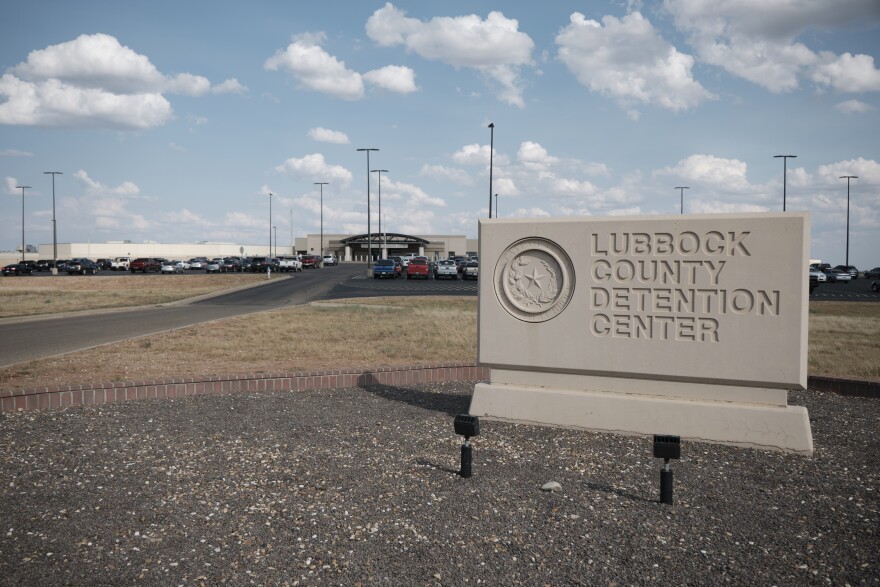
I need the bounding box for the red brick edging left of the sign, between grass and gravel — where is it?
[0,363,489,413]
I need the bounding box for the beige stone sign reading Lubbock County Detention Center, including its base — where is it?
[470,212,813,453]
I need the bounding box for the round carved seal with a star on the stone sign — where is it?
[494,237,574,322]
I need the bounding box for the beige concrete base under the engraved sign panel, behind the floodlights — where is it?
[470,369,813,455]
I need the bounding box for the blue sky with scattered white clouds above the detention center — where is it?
[0,0,880,268]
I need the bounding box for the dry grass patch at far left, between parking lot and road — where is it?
[0,274,266,318]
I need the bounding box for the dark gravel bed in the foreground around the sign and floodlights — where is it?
[0,383,880,586]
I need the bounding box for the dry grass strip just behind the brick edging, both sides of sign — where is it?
[0,296,880,388]
